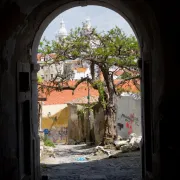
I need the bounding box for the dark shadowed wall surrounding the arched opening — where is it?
[0,0,180,180]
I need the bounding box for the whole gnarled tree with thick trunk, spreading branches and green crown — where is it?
[38,27,140,144]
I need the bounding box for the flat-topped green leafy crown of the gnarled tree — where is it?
[39,27,139,68]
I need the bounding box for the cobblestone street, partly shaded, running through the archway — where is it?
[41,145,141,180]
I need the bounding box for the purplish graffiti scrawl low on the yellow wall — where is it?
[48,126,67,143]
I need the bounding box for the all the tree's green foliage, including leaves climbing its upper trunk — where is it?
[39,23,140,114]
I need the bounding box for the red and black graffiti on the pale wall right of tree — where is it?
[117,113,139,134]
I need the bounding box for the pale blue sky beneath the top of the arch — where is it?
[42,6,134,40]
